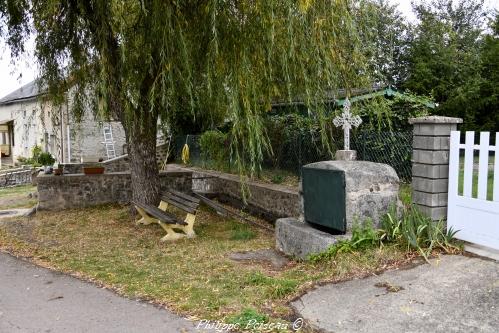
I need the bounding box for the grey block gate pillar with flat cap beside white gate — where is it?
[409,116,463,220]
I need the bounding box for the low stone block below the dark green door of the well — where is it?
[275,217,351,259]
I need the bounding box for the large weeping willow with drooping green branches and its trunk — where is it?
[0,0,372,204]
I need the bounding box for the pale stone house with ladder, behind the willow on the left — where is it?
[0,81,126,165]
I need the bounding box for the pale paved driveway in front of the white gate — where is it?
[292,256,499,333]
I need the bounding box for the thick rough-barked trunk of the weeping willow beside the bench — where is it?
[128,117,160,206]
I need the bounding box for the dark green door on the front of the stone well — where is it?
[302,166,346,233]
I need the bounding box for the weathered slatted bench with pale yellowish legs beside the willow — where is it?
[133,191,200,242]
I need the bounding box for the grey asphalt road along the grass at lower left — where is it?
[0,253,208,333]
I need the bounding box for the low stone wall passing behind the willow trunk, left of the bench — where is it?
[37,170,192,210]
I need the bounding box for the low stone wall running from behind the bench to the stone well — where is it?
[188,169,300,221]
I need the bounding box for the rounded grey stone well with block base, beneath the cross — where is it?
[275,161,399,258]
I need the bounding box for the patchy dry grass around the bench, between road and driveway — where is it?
[0,202,416,330]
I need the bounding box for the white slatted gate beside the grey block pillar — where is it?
[447,131,499,250]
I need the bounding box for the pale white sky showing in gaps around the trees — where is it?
[0,0,499,98]
